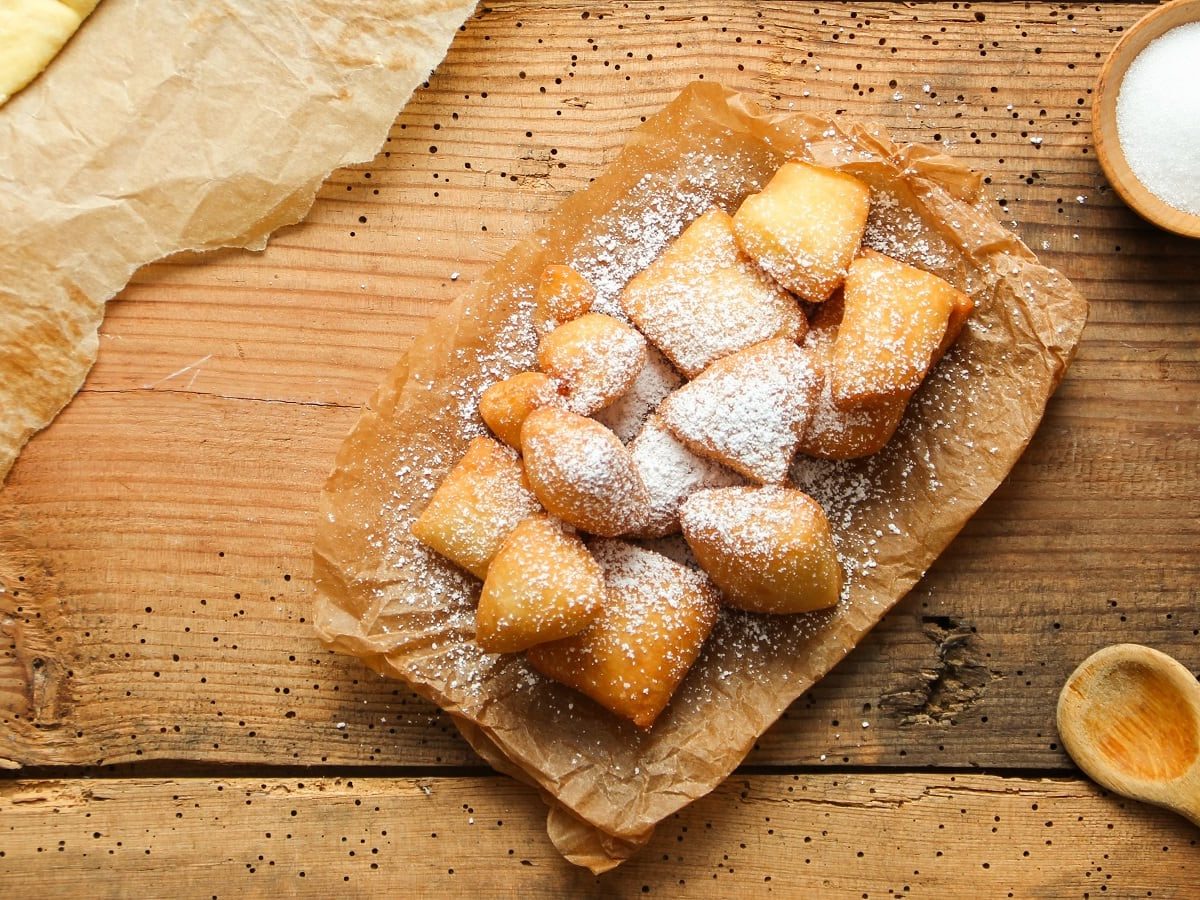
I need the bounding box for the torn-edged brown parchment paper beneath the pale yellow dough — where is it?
[0,0,475,481]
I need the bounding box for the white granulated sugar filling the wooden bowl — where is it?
[1117,22,1200,215]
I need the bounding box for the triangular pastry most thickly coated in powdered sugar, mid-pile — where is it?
[659,337,817,484]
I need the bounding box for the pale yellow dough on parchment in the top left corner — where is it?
[0,0,100,104]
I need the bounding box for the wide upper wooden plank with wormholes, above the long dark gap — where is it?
[0,4,1200,768]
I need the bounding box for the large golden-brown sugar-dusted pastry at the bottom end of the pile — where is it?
[527,541,718,728]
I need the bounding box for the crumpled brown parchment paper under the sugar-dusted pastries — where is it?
[314,83,1087,871]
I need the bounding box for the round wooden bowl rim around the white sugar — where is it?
[1092,0,1200,238]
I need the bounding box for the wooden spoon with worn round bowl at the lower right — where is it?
[1058,643,1200,824]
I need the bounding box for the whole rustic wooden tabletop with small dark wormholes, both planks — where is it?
[0,0,1200,898]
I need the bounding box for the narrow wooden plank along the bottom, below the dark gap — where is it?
[0,775,1200,898]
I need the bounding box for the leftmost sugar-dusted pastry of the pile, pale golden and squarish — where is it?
[413,438,539,578]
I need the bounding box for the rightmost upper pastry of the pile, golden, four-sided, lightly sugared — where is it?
[829,251,971,408]
